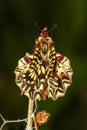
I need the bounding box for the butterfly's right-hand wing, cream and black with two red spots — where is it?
[48,53,73,100]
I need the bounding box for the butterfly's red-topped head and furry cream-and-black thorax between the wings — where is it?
[35,28,53,60]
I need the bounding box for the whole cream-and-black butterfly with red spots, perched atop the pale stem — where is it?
[14,27,73,100]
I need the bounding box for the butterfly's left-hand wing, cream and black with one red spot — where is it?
[14,53,37,98]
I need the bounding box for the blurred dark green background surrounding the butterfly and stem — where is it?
[0,0,87,130]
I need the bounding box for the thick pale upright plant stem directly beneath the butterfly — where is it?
[26,99,34,130]
